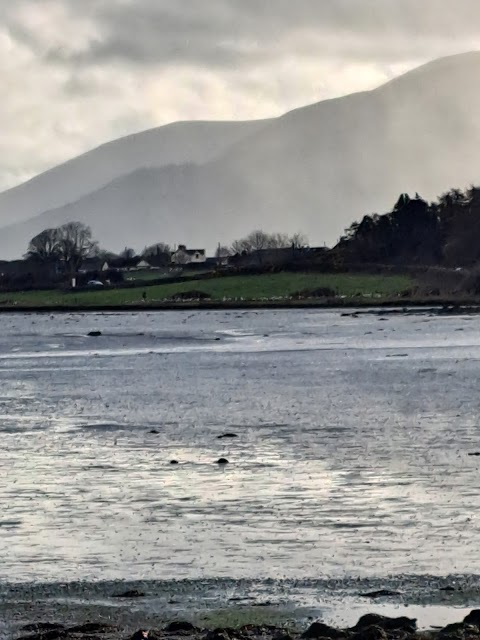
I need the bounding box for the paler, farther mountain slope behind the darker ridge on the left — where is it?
[0,121,268,225]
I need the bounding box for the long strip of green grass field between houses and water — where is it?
[0,273,414,307]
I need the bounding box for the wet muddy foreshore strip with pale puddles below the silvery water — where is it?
[4,576,480,640]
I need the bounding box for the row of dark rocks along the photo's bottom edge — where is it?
[12,609,480,640]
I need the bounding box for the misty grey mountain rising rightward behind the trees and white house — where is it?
[0,52,480,256]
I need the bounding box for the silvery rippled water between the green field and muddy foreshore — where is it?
[0,311,480,582]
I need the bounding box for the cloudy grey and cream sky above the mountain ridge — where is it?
[0,0,480,189]
